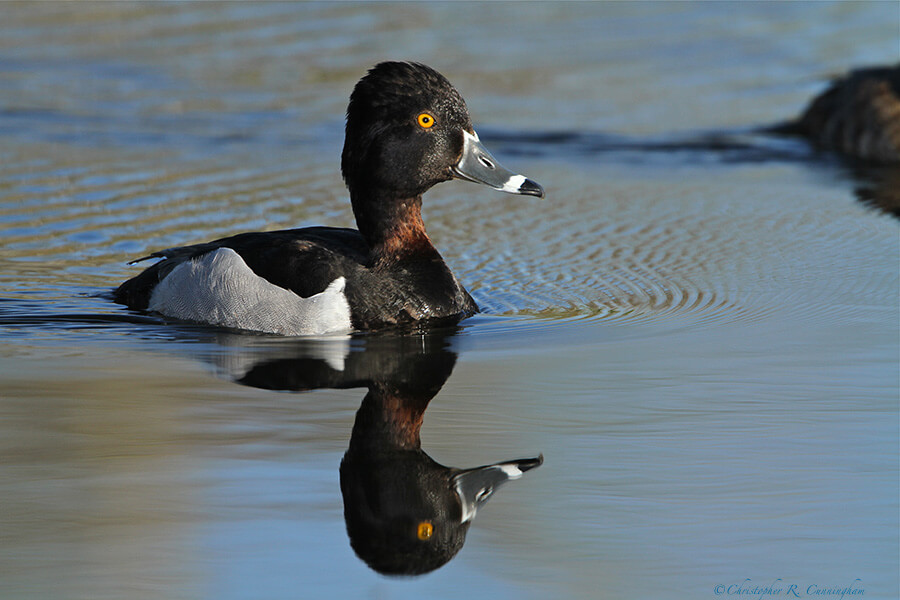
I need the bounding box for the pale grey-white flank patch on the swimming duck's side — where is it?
[148,248,351,335]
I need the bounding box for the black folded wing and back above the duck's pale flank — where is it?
[114,227,369,310]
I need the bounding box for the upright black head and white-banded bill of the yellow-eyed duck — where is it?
[341,62,544,198]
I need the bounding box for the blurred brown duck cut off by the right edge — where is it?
[774,65,900,163]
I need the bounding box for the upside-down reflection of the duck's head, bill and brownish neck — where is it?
[340,381,543,575]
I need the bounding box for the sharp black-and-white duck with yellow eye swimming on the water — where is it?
[113,61,544,336]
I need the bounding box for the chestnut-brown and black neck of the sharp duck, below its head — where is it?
[350,190,437,264]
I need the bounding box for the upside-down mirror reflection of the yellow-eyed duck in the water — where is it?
[221,333,543,575]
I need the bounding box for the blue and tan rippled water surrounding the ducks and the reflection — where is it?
[0,2,900,600]
